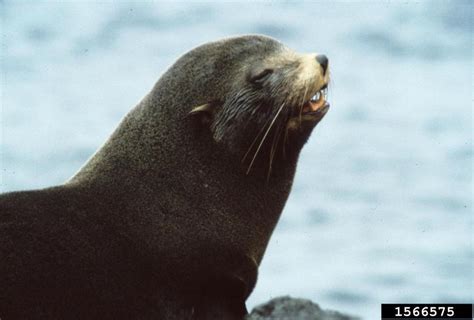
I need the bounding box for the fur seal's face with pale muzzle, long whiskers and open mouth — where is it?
[191,36,329,173]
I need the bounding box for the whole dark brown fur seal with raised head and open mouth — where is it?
[0,35,329,319]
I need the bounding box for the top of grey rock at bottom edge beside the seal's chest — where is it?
[246,296,359,320]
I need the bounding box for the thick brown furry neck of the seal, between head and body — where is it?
[66,76,296,262]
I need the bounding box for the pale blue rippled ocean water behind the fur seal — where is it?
[0,1,474,319]
